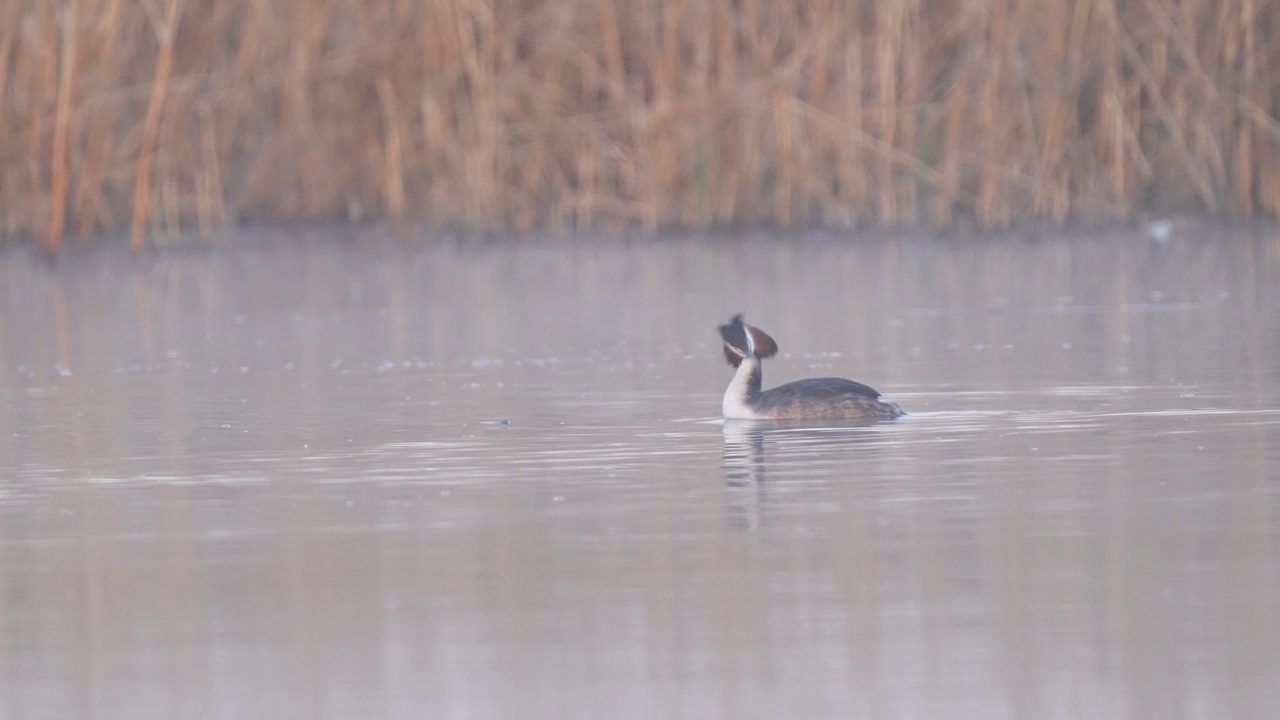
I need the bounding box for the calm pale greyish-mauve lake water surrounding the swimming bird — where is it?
[0,227,1280,720]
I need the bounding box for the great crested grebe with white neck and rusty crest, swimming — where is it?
[719,313,904,420]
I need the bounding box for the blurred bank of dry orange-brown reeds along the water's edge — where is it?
[0,0,1280,249]
